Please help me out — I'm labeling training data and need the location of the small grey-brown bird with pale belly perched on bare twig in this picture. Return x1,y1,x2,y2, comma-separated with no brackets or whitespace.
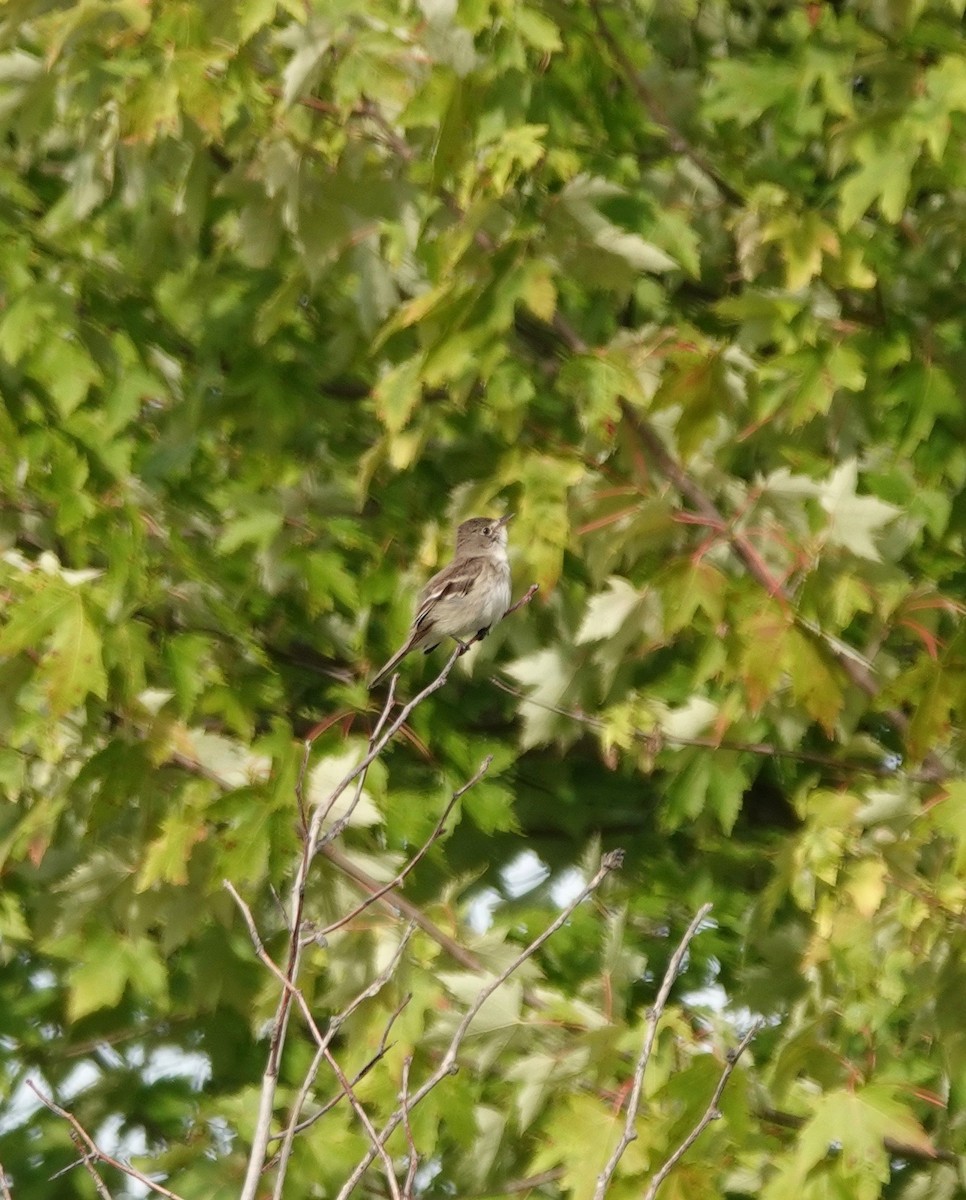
370,515,510,688
